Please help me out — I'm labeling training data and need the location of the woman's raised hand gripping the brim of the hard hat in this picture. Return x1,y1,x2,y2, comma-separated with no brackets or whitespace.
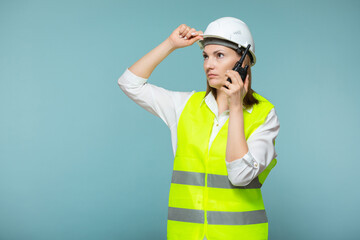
168,24,204,49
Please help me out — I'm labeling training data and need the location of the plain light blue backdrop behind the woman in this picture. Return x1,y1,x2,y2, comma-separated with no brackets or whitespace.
0,0,360,240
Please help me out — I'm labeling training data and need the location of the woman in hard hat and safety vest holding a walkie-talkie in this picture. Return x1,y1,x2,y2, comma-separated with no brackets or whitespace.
118,17,280,240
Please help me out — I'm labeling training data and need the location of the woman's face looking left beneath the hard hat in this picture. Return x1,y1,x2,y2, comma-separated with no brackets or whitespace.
203,44,240,89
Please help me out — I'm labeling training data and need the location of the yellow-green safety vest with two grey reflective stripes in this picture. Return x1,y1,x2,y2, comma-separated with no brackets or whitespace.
167,92,276,240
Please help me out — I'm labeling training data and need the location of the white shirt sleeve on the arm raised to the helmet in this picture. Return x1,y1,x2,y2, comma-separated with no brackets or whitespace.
118,68,194,128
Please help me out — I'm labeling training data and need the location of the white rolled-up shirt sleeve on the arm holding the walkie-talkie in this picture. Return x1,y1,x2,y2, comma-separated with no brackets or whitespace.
226,108,280,186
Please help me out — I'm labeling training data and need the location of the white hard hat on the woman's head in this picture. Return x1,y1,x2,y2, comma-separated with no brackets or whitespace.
197,17,256,66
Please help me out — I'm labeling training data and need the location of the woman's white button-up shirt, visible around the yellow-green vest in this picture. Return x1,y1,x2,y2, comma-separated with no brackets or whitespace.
118,68,280,186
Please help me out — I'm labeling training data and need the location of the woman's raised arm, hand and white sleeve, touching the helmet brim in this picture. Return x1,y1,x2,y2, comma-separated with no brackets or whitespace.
118,24,202,128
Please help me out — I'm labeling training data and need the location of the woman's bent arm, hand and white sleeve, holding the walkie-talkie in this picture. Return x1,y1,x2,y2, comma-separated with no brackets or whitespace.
221,70,280,186
